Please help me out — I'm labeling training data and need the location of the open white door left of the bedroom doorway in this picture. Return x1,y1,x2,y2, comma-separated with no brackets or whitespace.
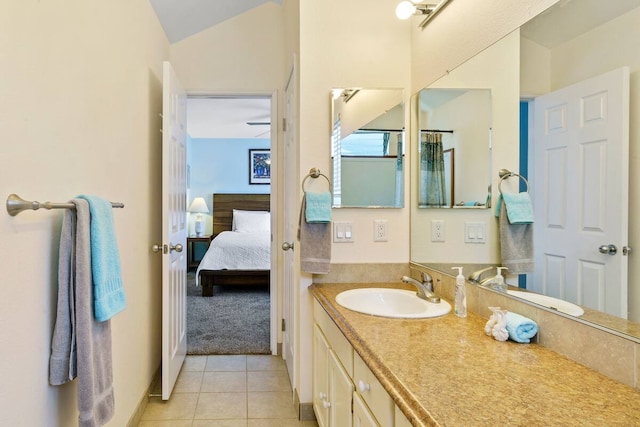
162,62,187,400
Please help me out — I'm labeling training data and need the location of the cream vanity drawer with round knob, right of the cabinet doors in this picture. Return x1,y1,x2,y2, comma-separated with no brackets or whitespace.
353,353,395,426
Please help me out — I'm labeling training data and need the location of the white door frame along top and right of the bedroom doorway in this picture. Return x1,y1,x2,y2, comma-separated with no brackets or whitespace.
186,89,280,356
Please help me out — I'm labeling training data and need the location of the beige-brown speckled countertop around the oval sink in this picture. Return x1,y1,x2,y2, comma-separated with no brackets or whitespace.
310,283,640,426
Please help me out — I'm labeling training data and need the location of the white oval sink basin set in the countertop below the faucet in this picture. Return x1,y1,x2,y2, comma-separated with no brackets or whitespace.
336,288,451,319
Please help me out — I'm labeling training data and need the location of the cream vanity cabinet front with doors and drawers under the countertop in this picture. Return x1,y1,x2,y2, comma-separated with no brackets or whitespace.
313,301,396,427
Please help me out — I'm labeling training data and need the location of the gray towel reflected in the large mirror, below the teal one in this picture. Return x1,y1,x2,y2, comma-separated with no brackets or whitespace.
498,203,533,274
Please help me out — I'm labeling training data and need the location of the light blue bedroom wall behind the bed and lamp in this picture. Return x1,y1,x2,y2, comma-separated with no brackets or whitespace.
188,138,271,234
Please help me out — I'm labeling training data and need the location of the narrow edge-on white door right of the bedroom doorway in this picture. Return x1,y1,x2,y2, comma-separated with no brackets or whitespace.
282,64,298,384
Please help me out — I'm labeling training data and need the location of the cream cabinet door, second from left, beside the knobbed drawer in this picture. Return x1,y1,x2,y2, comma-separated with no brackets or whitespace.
329,350,354,427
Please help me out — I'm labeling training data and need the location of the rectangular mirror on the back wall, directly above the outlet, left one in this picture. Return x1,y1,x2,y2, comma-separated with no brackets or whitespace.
331,88,404,208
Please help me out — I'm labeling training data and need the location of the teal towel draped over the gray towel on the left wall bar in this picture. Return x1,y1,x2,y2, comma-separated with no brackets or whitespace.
78,195,126,322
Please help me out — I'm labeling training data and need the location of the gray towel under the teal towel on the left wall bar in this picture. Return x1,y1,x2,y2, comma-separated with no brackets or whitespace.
49,199,115,427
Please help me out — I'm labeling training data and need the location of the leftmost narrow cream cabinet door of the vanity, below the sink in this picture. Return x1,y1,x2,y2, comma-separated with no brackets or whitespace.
312,324,331,427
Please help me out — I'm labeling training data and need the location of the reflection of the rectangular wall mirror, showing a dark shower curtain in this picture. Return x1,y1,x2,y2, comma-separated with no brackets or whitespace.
418,88,491,208
